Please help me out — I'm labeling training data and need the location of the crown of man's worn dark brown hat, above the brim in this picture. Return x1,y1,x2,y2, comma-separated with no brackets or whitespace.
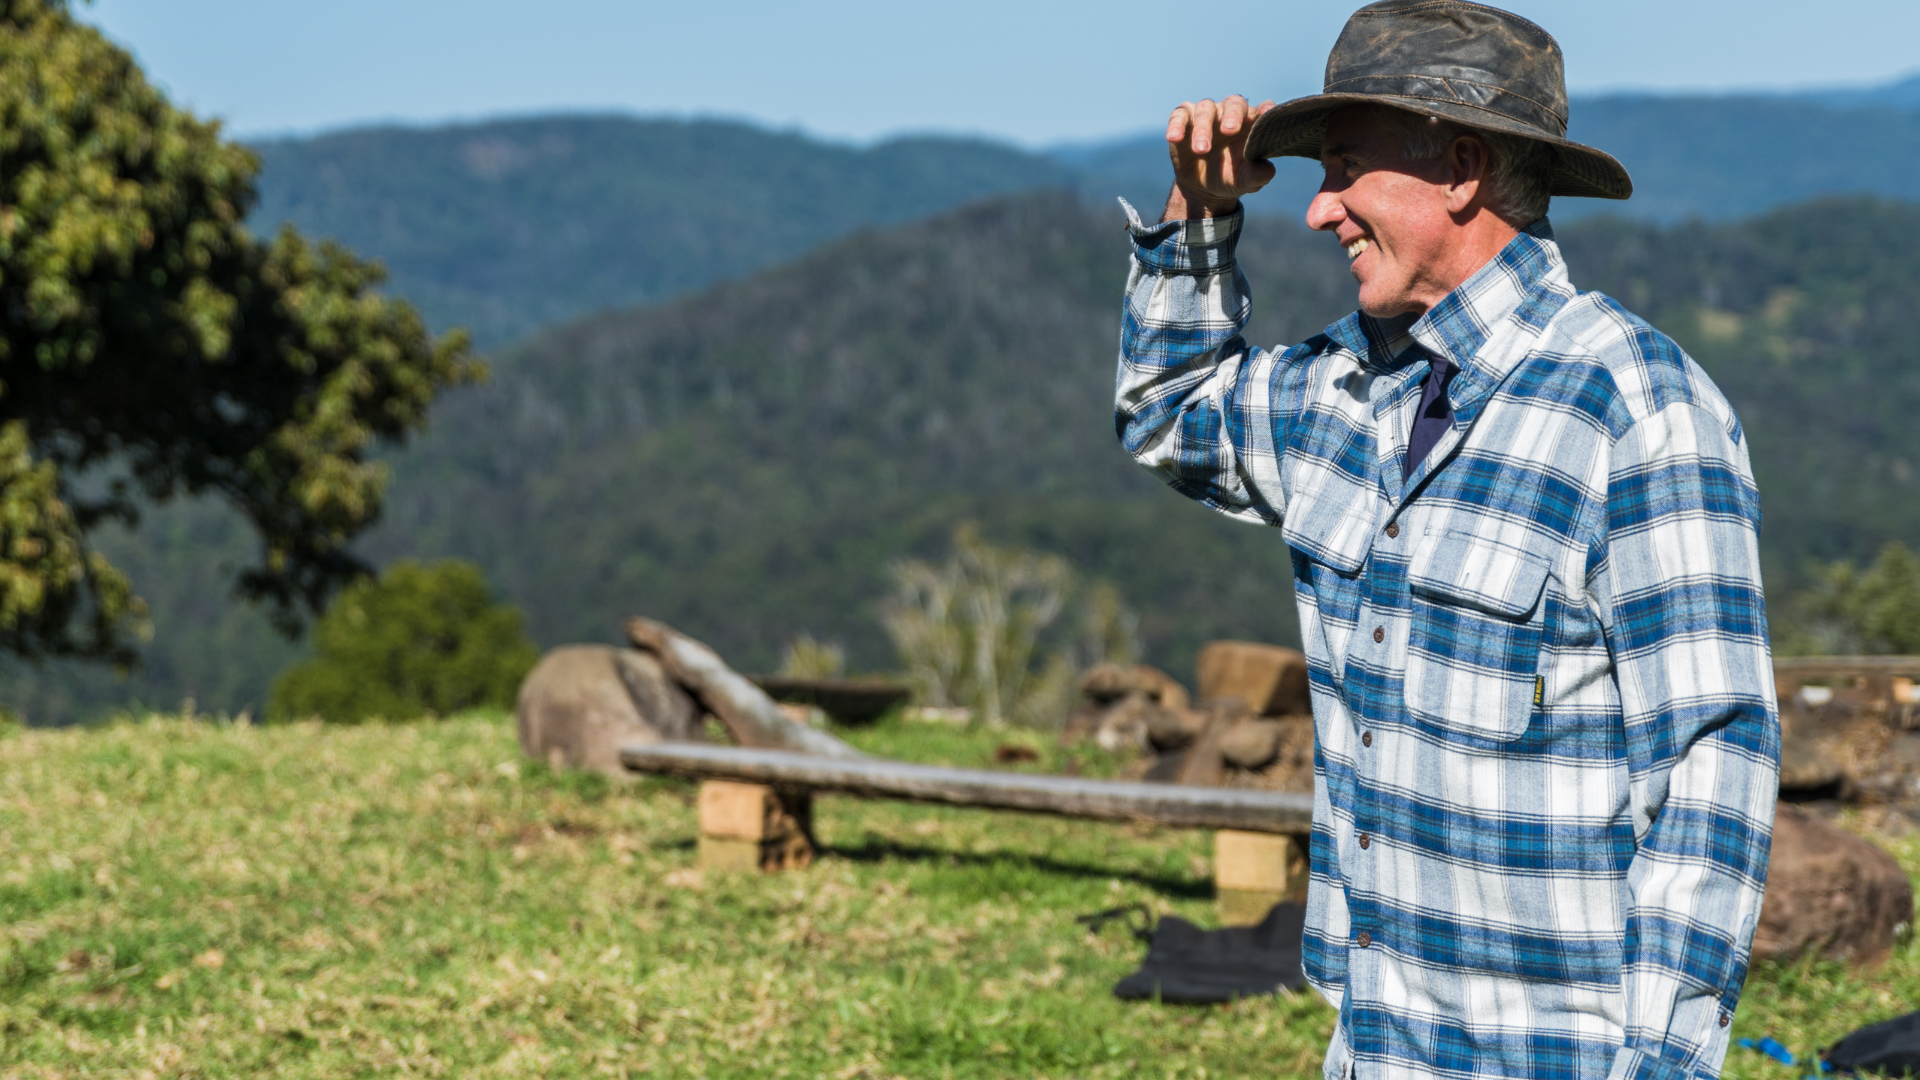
1325,0,1567,136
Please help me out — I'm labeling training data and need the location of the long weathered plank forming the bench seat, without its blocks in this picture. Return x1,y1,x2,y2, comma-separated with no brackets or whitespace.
620,744,1313,836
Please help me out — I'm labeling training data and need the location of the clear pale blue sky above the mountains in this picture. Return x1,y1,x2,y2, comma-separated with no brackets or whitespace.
77,0,1920,144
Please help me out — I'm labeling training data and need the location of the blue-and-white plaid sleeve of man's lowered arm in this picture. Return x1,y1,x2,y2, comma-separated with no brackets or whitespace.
1590,402,1780,1080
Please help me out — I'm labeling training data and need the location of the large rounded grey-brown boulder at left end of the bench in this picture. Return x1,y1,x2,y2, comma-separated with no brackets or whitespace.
515,646,707,776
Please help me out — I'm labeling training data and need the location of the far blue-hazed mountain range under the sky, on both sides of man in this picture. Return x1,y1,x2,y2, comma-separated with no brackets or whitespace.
252,83,1920,350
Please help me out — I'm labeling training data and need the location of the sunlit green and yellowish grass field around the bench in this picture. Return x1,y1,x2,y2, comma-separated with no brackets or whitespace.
0,717,1920,1080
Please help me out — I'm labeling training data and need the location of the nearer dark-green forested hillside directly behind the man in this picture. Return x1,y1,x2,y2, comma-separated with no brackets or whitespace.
8,194,1920,715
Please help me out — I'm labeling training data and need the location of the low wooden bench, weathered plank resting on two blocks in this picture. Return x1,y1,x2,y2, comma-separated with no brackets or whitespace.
620,744,1313,924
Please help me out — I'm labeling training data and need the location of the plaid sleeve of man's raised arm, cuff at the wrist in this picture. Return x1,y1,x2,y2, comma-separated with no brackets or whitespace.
1116,200,1290,525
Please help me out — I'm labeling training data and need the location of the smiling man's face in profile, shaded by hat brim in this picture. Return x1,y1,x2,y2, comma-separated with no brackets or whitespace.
1308,108,1459,319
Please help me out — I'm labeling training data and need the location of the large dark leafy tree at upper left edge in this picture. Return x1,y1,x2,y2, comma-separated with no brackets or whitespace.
0,0,480,661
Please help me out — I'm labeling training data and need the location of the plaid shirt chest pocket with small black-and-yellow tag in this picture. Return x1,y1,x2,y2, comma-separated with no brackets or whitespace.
1405,532,1548,742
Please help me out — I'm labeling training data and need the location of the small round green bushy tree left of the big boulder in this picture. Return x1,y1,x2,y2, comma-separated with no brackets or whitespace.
271,559,540,723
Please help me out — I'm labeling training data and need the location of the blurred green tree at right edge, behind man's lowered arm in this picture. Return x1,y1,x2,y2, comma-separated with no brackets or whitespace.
1782,542,1920,655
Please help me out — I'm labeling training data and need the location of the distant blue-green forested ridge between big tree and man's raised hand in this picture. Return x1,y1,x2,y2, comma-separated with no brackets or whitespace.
252,115,1069,348
